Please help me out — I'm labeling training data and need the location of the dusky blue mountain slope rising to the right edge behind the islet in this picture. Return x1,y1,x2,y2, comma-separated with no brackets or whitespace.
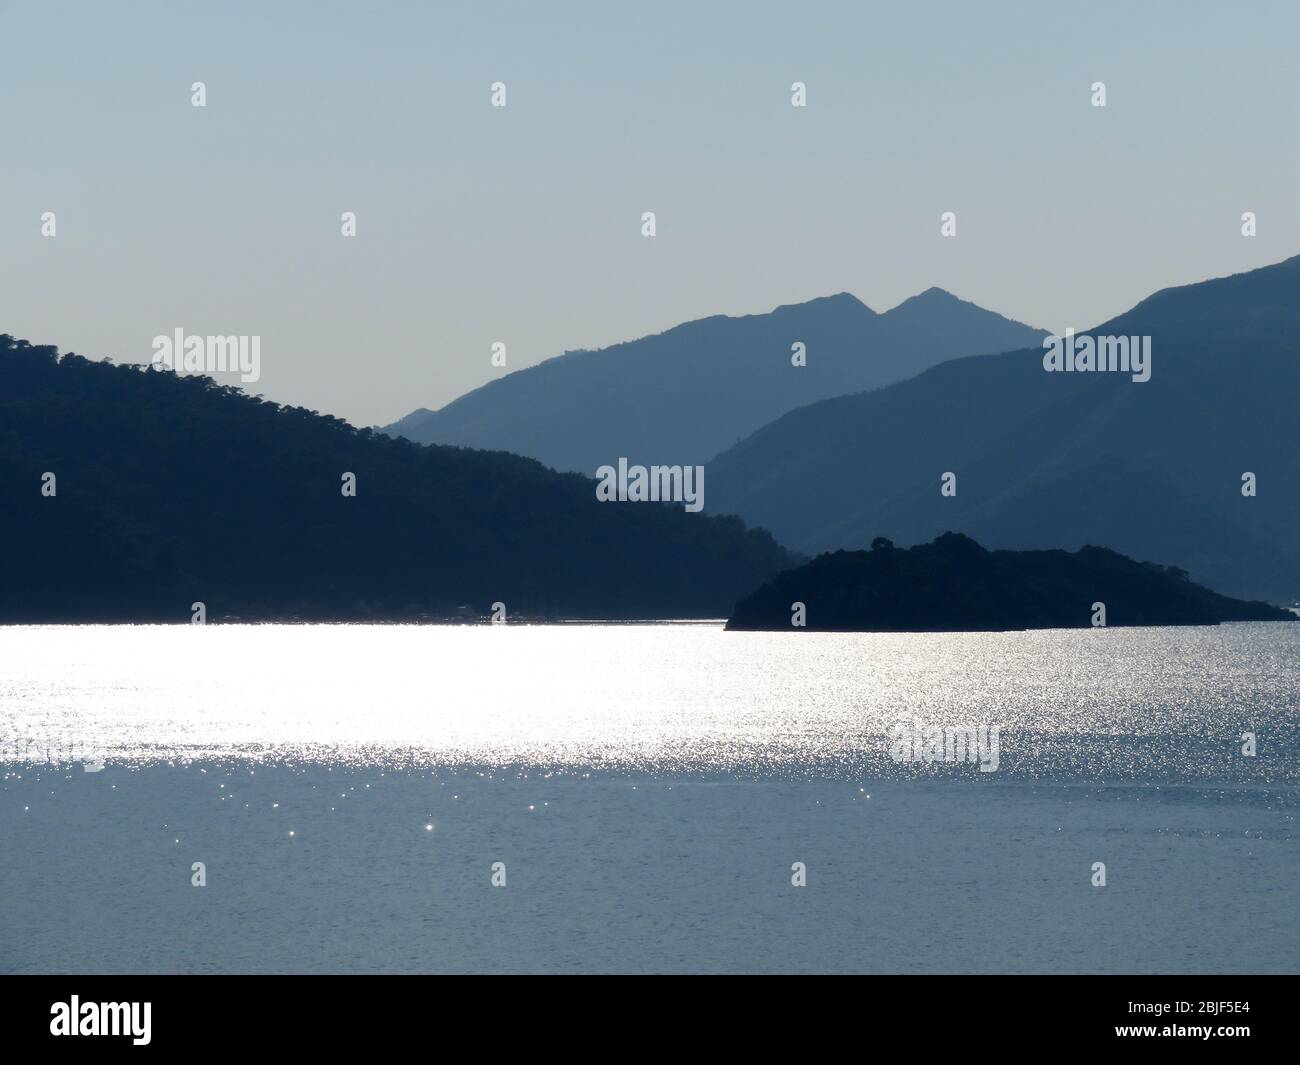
707,248,1300,602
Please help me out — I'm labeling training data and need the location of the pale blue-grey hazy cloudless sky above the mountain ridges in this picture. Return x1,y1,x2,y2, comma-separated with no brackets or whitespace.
0,0,1300,424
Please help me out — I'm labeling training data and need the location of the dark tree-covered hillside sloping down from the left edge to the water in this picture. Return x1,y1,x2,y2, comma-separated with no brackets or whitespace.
0,337,792,624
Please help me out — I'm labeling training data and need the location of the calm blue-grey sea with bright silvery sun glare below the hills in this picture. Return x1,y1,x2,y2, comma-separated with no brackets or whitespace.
0,624,1300,973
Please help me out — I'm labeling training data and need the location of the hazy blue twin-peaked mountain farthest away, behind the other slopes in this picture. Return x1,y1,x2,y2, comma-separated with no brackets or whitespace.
384,289,1043,475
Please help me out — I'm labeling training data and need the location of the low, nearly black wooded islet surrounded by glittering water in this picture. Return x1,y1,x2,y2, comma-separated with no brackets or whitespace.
727,533,1300,632
